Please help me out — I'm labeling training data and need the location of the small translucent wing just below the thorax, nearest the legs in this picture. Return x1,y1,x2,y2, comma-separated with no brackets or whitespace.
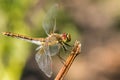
49,43,60,56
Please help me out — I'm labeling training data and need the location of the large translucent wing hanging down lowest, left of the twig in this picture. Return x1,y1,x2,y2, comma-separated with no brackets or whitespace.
35,46,52,77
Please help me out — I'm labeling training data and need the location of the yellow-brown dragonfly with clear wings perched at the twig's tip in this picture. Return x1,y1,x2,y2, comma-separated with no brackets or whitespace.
2,4,71,77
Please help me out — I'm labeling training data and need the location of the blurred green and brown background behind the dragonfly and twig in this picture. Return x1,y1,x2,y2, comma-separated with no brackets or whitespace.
0,0,120,80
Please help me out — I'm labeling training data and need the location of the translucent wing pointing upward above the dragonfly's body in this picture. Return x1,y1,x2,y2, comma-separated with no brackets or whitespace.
42,4,58,35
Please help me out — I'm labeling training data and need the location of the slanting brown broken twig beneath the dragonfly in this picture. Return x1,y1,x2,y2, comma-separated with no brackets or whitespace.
55,41,81,80
